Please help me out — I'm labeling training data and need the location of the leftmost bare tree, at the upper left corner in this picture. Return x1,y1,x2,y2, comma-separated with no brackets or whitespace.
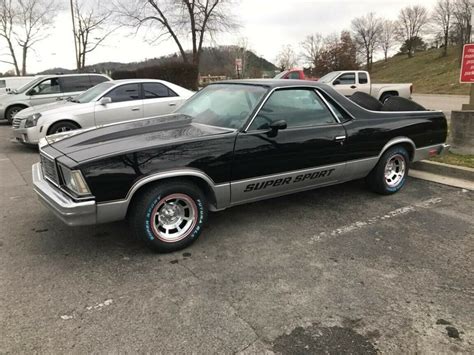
15,0,59,75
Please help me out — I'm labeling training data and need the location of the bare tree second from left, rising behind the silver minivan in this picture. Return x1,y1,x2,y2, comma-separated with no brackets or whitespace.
73,0,117,70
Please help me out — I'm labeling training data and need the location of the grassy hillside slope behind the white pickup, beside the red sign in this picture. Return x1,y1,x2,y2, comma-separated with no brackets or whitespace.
371,47,469,95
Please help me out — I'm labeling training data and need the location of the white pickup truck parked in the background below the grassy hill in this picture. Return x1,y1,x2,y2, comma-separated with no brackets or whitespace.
318,70,413,102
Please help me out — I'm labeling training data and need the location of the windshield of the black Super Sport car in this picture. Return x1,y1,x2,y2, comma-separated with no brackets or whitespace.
176,84,268,128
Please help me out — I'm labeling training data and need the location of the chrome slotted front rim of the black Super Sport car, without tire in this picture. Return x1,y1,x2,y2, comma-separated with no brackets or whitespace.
150,194,198,243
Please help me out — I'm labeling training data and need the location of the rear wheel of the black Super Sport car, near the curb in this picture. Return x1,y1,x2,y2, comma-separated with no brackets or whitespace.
366,146,410,195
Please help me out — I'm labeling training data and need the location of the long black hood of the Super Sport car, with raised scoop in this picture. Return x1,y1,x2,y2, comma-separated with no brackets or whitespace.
46,114,235,163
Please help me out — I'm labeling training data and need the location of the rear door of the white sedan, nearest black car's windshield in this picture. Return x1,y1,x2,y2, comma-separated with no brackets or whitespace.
142,82,184,117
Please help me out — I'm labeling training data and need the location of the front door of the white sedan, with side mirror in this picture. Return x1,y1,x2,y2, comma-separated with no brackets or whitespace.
95,83,143,126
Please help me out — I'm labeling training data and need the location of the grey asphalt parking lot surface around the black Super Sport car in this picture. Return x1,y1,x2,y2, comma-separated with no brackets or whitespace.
0,123,474,354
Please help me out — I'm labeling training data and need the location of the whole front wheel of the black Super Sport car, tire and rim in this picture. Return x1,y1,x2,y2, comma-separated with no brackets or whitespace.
129,181,208,253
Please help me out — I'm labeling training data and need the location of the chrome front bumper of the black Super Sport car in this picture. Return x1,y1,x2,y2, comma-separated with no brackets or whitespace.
32,163,97,226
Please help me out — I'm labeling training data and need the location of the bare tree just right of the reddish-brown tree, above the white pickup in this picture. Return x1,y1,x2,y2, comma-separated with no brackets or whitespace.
352,12,382,71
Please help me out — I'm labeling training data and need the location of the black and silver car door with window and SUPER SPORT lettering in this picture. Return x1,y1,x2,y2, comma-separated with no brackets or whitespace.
231,88,346,204
